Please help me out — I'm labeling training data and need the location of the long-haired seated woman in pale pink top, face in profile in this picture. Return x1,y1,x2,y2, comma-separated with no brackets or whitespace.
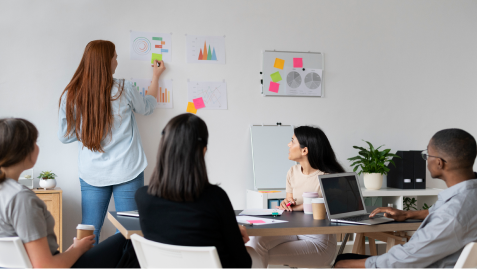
249,126,344,268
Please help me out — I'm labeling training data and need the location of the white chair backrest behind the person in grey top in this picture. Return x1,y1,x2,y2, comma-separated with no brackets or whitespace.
0,237,33,269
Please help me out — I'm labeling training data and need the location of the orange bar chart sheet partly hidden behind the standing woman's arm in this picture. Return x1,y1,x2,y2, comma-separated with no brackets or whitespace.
131,78,173,108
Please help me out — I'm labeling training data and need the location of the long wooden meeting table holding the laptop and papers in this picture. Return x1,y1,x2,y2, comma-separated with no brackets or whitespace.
108,210,421,254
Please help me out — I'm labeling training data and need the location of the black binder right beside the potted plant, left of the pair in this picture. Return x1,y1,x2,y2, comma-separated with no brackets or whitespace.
387,150,414,189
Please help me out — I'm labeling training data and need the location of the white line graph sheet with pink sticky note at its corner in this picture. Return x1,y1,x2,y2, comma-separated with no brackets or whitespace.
187,81,227,109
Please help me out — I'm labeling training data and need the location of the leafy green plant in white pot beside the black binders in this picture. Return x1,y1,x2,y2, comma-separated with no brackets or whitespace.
348,140,400,190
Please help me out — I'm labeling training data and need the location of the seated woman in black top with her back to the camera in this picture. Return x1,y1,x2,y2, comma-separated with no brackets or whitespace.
136,114,254,269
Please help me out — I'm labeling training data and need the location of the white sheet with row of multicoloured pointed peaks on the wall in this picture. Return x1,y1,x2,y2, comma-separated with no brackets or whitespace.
186,35,225,64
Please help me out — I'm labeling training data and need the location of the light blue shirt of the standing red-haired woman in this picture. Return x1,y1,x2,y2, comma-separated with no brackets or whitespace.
58,79,156,187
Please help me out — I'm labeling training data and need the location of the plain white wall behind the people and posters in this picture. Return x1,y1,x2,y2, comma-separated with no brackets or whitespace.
0,0,477,246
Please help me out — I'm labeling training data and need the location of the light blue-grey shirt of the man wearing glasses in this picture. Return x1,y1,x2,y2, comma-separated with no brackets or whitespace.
366,175,477,269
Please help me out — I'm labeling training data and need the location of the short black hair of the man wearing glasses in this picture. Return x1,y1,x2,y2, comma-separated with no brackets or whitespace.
431,129,477,167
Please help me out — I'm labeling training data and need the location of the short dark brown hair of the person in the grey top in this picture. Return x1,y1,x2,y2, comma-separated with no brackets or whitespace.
0,118,38,183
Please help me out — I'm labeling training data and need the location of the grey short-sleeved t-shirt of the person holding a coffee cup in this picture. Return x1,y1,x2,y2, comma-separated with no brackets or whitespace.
0,179,58,254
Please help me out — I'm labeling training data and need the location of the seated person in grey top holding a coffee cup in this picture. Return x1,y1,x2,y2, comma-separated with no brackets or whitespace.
0,118,137,269
